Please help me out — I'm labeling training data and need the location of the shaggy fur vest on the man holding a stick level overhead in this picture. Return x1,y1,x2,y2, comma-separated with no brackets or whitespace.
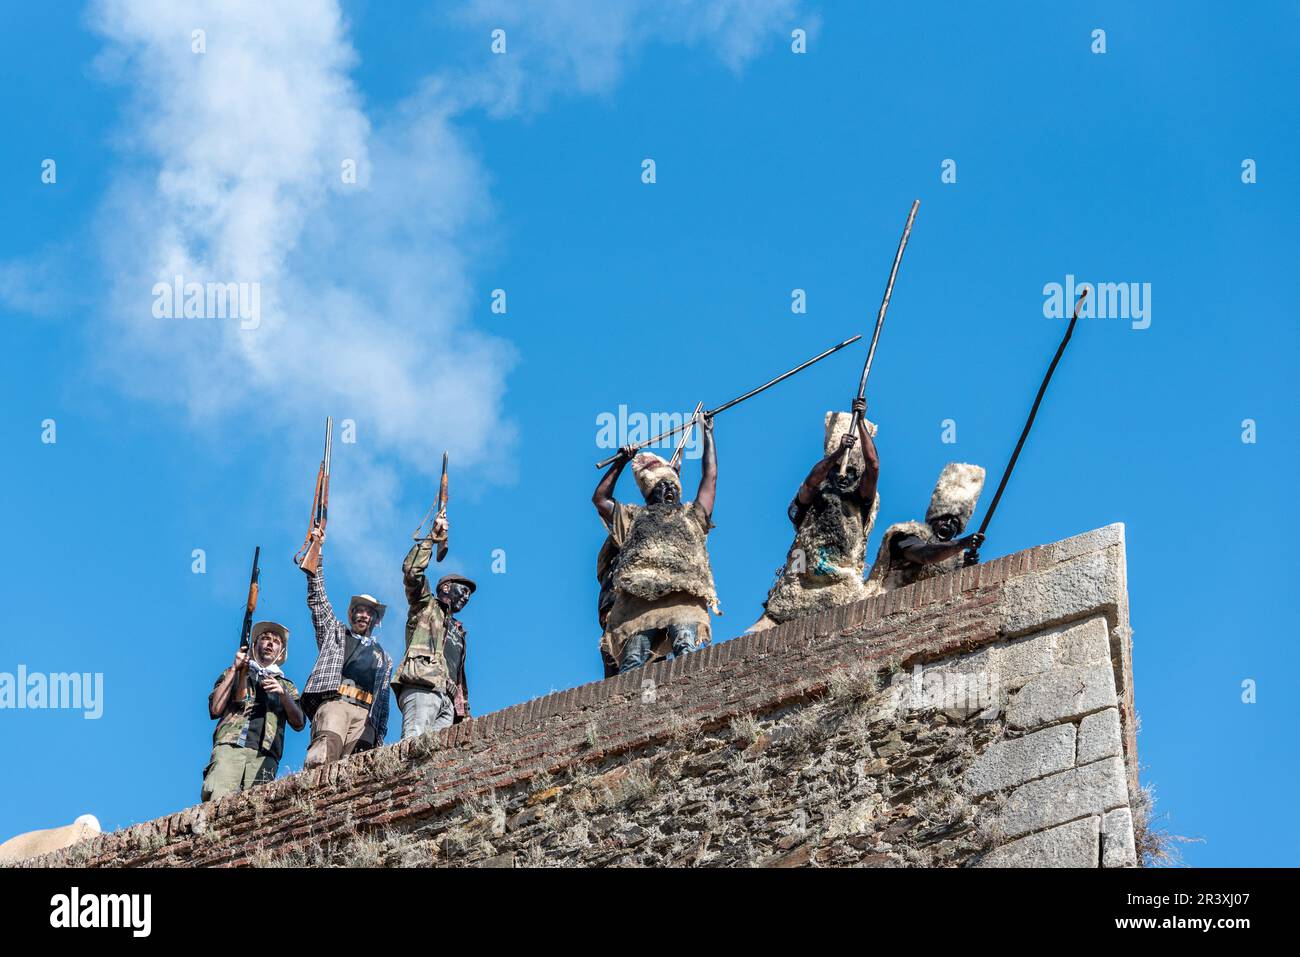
612,503,718,611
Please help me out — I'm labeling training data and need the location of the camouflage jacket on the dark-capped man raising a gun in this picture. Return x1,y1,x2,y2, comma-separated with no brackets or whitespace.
393,538,469,720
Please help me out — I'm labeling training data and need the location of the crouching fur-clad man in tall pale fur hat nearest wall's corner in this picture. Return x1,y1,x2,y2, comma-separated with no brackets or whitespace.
867,462,984,594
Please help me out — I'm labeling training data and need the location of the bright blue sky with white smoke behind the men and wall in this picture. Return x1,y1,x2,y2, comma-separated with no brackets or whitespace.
0,0,1300,865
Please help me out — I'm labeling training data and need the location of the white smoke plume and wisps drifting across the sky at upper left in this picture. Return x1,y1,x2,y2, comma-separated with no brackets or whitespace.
17,0,797,572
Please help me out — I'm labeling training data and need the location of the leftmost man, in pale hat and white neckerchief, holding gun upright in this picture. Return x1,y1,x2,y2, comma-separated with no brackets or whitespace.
202,622,307,801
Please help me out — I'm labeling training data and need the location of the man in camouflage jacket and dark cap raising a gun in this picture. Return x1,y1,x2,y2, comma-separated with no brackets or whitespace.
393,516,475,741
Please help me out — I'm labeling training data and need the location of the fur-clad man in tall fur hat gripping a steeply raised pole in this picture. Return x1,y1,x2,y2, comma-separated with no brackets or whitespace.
749,399,880,632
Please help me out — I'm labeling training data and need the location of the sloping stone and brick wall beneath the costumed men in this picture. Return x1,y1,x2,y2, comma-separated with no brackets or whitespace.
30,525,1138,867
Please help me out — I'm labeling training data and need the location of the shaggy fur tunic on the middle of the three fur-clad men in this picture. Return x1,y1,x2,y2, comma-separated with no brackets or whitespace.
764,482,880,623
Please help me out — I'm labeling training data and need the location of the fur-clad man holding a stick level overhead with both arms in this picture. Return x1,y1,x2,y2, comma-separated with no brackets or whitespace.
592,419,722,674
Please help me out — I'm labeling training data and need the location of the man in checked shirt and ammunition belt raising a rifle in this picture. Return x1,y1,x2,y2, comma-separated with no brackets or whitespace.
303,531,393,768
